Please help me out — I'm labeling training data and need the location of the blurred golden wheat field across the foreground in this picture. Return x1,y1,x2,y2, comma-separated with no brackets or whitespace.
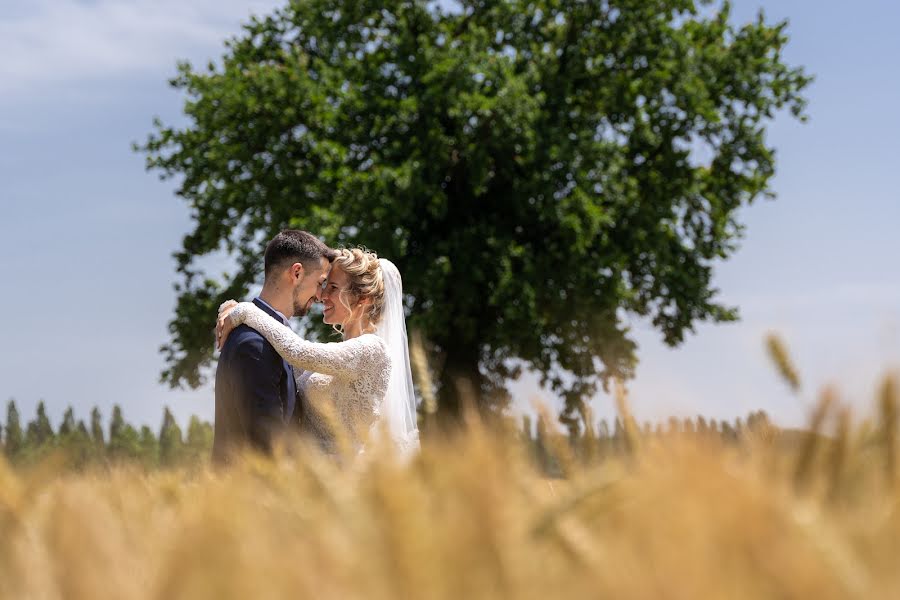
0,381,900,599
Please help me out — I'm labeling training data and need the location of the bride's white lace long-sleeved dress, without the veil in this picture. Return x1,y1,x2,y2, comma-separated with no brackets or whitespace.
229,302,391,451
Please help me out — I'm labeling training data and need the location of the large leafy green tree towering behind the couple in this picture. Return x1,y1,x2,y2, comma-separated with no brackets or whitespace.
137,0,810,416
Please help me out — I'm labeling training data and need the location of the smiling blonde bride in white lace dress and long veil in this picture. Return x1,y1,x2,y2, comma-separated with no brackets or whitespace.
216,248,419,453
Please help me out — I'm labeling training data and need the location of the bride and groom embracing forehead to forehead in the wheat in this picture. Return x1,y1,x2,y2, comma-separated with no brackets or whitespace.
213,230,419,463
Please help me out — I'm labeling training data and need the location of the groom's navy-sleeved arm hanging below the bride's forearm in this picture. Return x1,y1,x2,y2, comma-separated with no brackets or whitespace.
236,331,284,453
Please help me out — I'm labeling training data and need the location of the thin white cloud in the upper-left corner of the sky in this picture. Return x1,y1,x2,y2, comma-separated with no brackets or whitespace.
0,0,282,95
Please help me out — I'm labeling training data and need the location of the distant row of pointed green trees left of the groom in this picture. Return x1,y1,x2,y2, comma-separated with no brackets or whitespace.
0,400,213,469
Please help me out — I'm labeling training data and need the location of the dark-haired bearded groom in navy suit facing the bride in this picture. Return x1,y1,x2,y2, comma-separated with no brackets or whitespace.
213,230,335,463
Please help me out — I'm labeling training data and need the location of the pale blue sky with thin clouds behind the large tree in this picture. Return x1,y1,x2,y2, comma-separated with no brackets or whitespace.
0,0,900,426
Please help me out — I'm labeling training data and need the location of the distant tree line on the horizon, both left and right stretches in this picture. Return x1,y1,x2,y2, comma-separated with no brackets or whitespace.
0,400,773,476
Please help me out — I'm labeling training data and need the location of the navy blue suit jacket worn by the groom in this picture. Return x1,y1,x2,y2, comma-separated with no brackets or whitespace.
213,300,297,462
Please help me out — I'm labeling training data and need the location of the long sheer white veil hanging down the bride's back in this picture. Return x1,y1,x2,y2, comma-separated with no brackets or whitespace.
376,258,419,454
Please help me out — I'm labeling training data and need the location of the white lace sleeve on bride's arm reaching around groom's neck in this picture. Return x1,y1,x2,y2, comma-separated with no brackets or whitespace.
229,302,380,375
